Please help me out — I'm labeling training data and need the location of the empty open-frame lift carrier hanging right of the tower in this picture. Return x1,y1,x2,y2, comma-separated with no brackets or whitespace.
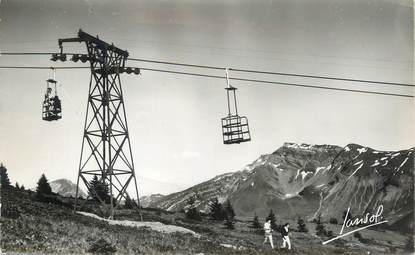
222,68,251,144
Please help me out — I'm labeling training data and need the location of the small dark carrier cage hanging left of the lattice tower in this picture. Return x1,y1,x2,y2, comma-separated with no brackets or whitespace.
42,70,62,121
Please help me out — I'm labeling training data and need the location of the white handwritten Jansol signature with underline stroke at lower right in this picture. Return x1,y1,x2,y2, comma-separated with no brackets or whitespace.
323,205,388,245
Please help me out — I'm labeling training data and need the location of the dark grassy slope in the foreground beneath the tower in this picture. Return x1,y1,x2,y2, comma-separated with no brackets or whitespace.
1,188,410,255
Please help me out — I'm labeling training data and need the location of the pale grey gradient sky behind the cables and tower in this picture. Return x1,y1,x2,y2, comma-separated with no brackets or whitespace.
0,0,415,195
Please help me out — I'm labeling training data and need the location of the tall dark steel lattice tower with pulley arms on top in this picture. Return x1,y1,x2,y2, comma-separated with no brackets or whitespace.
51,30,140,217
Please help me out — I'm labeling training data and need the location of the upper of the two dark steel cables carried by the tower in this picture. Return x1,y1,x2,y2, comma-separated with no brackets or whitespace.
0,52,415,87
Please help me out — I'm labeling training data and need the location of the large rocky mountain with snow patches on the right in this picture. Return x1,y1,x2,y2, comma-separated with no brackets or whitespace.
148,143,415,232
